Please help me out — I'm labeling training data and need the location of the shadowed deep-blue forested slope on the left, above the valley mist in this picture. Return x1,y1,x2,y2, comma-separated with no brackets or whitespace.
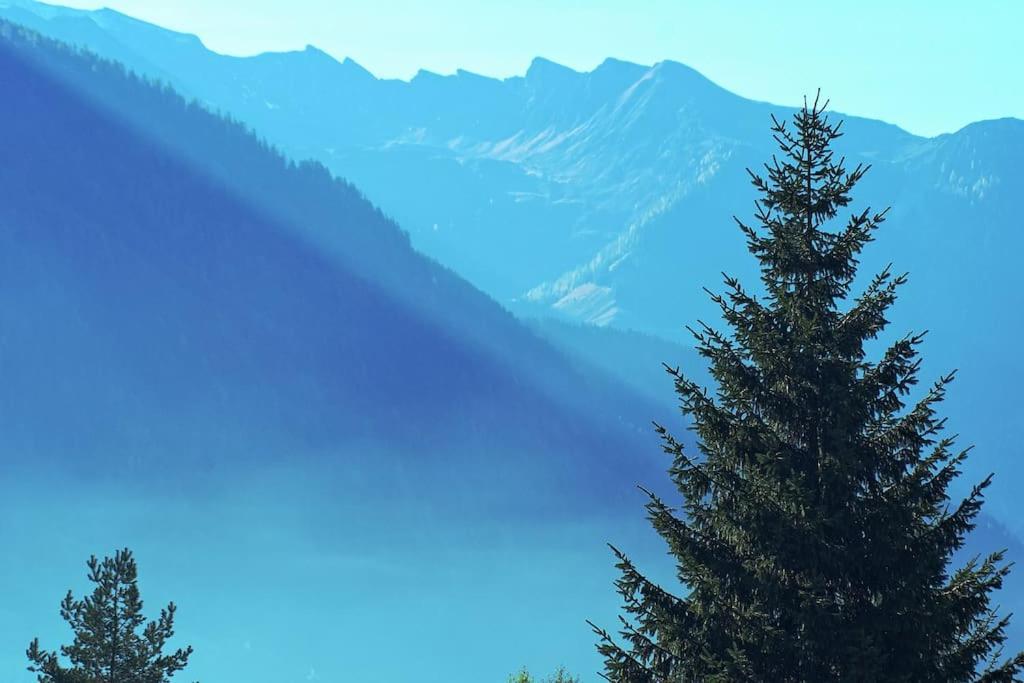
0,18,671,499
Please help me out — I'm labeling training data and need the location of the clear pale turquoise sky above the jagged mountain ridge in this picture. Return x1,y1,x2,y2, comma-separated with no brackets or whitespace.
59,0,1024,135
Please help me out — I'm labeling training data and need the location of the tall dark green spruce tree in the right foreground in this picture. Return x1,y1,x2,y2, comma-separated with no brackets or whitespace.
592,93,1024,683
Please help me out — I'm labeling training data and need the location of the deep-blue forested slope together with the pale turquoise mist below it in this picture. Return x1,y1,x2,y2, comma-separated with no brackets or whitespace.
0,23,679,681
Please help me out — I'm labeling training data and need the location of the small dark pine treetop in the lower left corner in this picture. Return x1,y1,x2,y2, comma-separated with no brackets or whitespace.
27,549,193,683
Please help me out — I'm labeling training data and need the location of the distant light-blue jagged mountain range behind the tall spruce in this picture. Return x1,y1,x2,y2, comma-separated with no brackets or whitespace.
16,0,1024,531
